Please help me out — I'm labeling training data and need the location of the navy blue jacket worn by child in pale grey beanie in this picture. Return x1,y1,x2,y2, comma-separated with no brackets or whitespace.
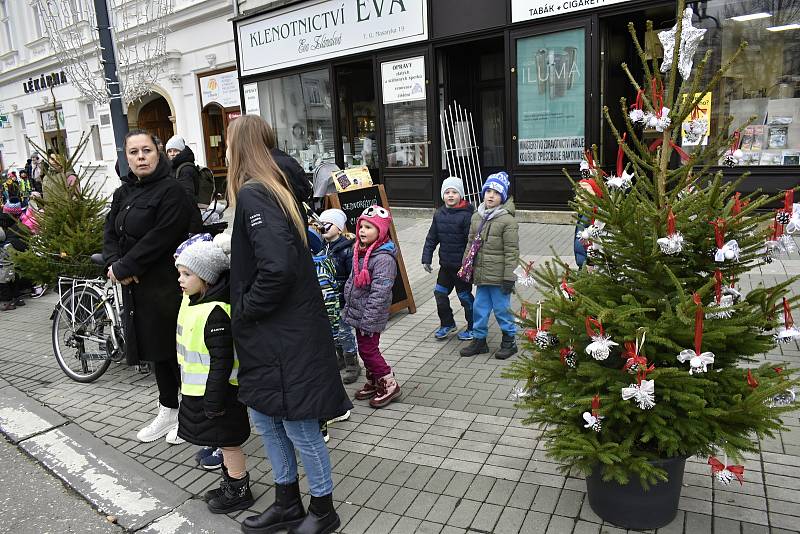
422,203,475,268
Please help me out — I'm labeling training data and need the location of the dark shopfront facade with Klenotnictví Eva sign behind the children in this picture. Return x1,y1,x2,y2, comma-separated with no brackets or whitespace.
234,0,800,209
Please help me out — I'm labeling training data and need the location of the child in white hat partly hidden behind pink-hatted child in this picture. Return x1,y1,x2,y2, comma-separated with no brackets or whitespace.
319,209,361,384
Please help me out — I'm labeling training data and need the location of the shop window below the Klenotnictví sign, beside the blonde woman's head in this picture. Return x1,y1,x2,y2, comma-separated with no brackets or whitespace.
258,70,335,172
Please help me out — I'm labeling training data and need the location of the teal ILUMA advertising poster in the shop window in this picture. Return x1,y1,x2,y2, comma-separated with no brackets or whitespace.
517,29,586,165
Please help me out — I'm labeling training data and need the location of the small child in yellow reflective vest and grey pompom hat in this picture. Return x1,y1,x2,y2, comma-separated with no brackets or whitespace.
175,234,254,514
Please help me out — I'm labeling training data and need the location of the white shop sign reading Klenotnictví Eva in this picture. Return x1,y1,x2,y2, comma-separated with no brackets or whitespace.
236,0,428,76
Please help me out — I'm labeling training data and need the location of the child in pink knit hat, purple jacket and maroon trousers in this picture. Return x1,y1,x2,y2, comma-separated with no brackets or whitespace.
342,206,400,408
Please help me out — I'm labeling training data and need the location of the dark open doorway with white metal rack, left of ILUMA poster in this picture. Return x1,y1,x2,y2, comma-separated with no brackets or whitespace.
438,37,506,186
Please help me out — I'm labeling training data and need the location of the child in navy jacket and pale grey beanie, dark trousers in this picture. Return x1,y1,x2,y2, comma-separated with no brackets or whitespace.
422,176,475,341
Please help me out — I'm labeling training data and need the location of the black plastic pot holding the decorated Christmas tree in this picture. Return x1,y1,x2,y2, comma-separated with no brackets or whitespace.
586,458,686,530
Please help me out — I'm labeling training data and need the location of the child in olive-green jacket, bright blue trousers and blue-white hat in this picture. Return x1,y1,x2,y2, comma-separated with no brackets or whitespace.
459,172,519,360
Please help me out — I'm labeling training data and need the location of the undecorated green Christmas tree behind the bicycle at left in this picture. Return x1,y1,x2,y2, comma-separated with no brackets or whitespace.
13,134,106,284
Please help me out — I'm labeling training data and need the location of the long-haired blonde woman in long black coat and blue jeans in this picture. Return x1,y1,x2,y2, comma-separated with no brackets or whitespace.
228,115,352,534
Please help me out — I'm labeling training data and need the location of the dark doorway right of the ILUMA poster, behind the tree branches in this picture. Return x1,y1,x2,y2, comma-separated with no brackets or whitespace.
599,6,675,169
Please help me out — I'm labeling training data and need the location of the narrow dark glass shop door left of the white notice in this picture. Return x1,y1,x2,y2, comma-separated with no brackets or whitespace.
334,61,380,183
